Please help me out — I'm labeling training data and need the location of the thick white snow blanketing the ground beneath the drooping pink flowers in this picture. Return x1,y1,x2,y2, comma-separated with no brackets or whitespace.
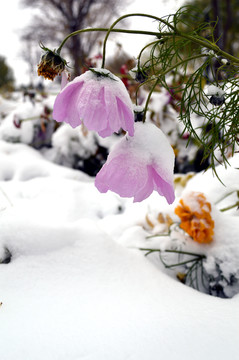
0,91,239,360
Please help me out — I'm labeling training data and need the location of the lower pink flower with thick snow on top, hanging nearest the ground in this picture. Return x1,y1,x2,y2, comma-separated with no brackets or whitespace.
95,123,175,204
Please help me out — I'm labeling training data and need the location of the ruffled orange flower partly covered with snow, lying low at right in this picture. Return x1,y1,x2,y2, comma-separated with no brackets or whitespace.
175,192,214,244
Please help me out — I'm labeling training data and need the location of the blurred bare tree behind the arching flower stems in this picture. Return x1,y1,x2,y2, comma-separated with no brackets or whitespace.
21,0,127,75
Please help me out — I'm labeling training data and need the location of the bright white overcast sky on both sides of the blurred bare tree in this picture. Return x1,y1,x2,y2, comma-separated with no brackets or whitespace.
0,0,183,84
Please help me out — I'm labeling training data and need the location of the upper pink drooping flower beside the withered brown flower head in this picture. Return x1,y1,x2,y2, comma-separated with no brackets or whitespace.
53,69,134,137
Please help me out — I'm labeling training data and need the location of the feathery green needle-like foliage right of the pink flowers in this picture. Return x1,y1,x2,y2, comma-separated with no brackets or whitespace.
136,7,239,177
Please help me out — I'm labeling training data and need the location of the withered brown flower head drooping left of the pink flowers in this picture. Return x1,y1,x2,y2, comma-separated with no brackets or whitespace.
37,45,66,80
